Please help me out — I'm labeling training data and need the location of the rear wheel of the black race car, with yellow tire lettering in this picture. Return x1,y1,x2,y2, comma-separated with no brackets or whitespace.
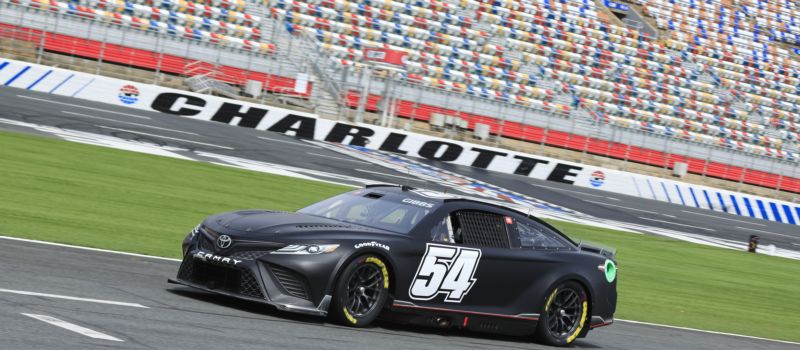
536,281,589,346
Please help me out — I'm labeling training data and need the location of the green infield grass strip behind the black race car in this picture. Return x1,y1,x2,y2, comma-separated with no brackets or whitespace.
0,132,800,341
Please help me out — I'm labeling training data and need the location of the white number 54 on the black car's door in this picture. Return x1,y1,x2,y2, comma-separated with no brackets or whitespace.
408,243,481,303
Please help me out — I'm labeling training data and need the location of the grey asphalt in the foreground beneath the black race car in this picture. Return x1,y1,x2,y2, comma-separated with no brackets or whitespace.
0,239,800,350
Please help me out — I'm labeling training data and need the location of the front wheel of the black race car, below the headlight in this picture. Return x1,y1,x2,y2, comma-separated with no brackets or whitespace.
328,255,389,327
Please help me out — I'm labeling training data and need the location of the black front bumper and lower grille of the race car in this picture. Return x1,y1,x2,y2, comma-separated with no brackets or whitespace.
168,247,331,316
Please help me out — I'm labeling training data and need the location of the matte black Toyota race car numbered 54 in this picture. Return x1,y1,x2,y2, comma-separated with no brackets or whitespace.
170,185,617,345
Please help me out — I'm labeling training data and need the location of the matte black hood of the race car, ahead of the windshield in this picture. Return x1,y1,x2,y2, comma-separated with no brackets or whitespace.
205,210,391,237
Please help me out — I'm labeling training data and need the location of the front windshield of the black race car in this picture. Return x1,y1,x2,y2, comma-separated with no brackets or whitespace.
297,189,439,233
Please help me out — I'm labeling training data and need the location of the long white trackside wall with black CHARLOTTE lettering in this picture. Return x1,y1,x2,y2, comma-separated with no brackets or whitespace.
0,60,800,225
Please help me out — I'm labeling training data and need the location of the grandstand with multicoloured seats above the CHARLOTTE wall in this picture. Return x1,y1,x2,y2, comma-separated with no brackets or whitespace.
0,0,800,198
